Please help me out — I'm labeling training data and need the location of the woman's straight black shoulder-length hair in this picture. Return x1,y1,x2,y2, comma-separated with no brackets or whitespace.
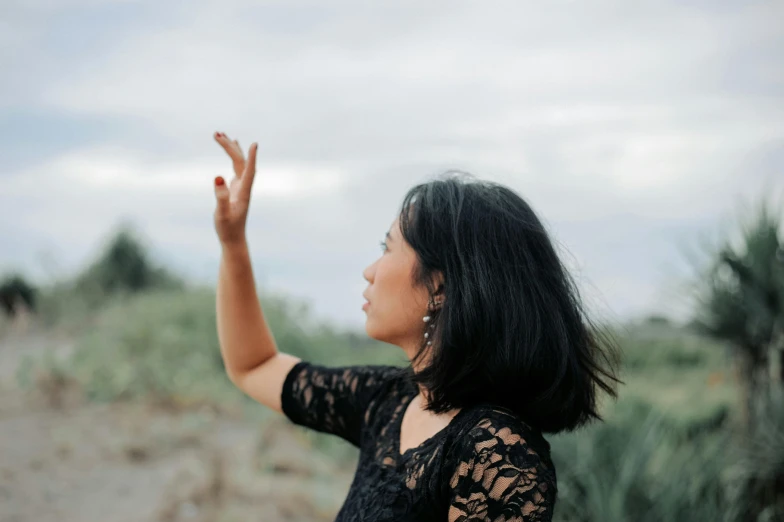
400,171,621,433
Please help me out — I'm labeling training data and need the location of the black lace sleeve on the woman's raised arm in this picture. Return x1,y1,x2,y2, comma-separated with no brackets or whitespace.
281,361,400,447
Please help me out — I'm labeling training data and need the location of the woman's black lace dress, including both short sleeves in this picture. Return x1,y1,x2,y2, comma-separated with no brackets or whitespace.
281,361,556,522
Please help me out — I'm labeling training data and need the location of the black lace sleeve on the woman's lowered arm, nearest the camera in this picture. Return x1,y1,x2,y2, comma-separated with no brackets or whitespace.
449,418,556,522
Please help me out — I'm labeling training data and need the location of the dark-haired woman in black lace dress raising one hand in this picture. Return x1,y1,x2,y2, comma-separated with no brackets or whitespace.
215,133,618,522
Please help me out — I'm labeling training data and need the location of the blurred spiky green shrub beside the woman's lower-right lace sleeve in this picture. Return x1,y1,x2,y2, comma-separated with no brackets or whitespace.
551,402,725,522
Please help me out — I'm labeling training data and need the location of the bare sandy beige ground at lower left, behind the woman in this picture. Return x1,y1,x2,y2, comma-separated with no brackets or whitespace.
0,332,353,522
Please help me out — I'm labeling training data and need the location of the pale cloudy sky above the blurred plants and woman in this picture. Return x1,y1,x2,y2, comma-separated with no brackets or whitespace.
0,0,784,326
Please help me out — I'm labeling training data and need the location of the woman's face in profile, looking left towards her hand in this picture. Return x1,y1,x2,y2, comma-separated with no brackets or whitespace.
362,212,438,357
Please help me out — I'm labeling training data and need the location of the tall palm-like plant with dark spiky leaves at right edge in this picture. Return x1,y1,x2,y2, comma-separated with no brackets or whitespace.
695,195,784,520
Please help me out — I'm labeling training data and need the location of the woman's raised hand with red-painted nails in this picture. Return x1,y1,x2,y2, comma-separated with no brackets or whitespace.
214,132,258,246
